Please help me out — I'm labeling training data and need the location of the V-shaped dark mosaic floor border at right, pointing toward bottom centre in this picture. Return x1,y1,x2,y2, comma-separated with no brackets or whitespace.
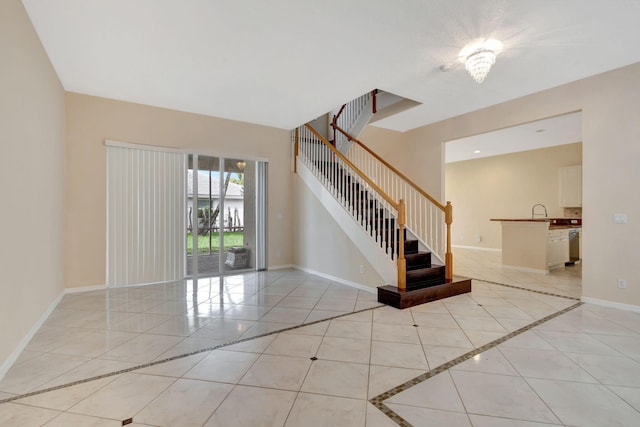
369,300,582,427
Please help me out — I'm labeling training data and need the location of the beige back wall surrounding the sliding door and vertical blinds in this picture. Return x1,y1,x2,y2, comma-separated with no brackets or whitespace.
65,93,293,287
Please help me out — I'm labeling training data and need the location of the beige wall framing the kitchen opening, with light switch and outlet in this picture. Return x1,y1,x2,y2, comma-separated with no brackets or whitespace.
378,64,640,306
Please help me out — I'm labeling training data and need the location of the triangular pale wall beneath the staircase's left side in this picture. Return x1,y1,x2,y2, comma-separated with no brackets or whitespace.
293,176,386,288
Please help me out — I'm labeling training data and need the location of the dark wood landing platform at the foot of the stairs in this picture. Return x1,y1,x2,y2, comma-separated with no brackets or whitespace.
378,276,471,308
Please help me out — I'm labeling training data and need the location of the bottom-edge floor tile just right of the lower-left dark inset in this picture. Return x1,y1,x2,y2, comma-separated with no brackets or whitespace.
135,379,233,427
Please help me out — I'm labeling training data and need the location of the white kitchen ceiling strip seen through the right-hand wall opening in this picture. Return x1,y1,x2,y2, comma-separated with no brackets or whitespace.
445,112,582,163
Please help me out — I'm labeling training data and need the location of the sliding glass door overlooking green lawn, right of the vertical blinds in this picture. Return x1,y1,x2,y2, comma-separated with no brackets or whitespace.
186,155,266,277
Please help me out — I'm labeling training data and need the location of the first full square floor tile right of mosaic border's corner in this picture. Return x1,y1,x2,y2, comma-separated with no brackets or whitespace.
451,371,558,423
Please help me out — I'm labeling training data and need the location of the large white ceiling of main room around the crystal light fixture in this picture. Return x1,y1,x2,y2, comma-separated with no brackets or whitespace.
23,0,640,131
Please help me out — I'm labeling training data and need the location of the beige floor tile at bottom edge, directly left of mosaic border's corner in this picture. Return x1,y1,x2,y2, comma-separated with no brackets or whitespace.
285,393,367,427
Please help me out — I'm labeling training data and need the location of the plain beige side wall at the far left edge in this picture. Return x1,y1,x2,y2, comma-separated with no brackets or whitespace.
0,0,64,370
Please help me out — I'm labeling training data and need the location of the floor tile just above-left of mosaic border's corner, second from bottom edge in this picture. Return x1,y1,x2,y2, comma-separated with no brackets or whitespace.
301,360,369,399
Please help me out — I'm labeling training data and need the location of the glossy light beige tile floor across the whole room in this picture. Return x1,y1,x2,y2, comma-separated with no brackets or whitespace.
0,251,640,427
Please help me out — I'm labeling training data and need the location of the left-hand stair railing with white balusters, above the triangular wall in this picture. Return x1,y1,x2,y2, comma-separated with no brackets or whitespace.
292,124,406,290
